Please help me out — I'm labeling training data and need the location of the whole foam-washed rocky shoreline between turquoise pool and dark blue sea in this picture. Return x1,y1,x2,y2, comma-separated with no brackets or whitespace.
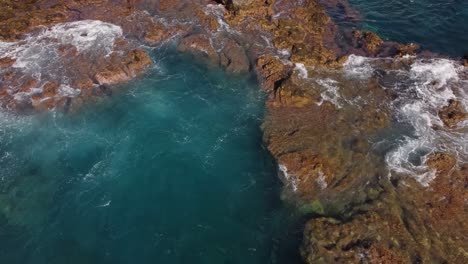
0,0,468,263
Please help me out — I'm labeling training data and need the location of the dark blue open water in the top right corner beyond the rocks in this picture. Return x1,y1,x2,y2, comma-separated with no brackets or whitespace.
349,0,468,57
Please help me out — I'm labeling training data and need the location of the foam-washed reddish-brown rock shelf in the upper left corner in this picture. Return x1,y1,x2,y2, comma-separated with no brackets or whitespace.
0,0,193,113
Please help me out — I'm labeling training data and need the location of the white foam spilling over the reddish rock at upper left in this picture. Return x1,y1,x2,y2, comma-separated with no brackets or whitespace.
0,20,123,104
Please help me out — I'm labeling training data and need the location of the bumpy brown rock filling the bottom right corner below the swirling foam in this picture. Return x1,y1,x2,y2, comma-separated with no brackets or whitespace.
301,150,468,263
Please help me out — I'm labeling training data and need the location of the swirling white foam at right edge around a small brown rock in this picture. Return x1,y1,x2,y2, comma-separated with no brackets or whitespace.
386,59,468,186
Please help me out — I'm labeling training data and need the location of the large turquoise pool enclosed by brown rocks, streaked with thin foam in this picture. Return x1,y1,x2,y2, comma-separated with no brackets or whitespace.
0,51,301,264
